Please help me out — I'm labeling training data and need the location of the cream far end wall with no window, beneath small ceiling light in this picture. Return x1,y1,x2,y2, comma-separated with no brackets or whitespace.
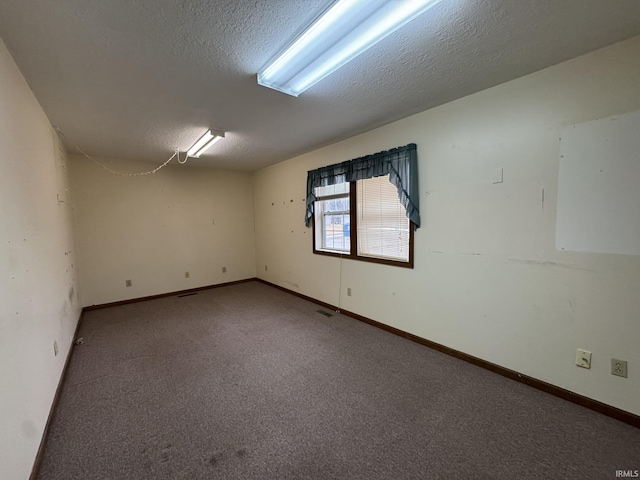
70,155,255,306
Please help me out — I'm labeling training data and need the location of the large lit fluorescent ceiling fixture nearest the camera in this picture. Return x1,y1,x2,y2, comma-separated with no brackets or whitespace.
258,0,441,97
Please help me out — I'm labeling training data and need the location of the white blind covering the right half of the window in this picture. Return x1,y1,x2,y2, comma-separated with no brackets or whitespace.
356,175,410,262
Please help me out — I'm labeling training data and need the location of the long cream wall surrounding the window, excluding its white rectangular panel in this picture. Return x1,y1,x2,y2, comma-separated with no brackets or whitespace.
254,37,640,414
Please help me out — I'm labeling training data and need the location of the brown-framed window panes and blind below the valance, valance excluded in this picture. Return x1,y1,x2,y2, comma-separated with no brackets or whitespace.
313,175,413,268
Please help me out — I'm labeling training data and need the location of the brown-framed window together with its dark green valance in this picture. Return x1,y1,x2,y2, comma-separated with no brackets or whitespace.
304,143,420,268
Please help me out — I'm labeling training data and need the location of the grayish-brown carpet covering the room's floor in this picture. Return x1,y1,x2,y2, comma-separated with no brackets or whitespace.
38,282,640,480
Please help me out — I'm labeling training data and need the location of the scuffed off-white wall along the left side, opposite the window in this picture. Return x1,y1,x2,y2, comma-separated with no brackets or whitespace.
0,40,80,479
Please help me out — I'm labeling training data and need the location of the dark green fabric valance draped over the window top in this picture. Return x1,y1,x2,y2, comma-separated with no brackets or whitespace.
305,143,420,228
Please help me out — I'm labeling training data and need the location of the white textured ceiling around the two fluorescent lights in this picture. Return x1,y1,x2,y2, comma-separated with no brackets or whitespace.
0,0,640,170
